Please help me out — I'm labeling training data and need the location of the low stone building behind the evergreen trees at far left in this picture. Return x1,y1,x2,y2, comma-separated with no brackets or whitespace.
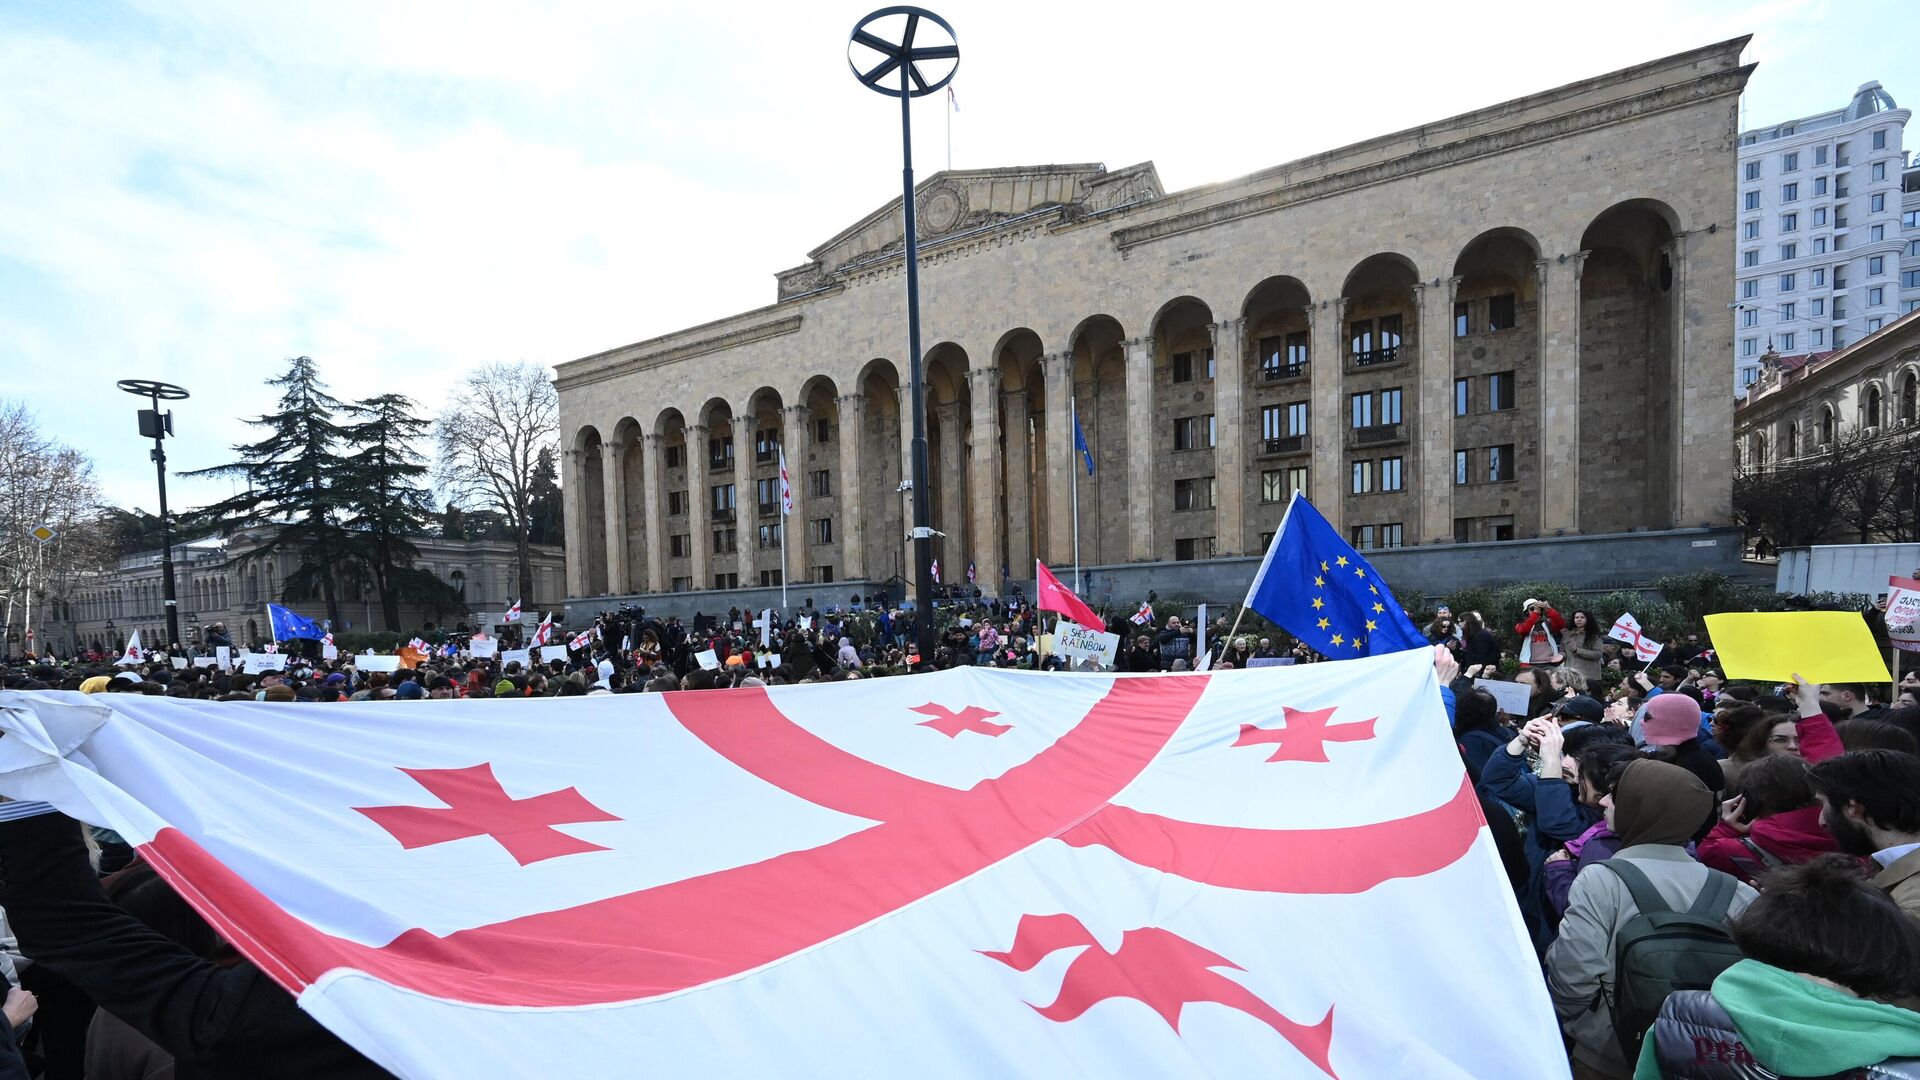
46,532,566,650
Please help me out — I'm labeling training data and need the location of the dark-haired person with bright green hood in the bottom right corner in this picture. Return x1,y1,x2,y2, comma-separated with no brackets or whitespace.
1634,855,1920,1080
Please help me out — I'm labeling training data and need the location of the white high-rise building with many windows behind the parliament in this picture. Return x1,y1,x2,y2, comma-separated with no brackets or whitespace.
1732,83,1920,396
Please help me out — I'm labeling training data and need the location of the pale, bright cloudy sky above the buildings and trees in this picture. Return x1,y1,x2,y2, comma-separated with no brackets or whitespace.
0,0,1920,509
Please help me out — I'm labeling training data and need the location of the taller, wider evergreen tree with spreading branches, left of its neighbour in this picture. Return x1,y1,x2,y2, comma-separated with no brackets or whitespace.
182,356,349,625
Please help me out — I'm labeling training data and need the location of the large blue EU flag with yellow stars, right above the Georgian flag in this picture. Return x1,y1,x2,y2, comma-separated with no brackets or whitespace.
1246,492,1427,659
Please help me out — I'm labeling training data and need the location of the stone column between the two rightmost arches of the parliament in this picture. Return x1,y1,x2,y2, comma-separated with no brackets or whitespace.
1534,252,1586,536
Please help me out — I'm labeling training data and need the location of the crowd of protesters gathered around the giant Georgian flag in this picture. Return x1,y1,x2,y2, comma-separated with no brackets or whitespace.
0,596,1920,1080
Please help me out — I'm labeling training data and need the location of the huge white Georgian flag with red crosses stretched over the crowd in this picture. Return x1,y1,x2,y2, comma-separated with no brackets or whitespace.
0,650,1567,1080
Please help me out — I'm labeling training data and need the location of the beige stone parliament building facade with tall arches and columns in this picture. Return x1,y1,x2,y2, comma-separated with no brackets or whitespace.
557,38,1751,598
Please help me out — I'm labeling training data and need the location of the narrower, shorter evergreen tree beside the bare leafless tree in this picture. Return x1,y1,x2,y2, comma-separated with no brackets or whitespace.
334,394,438,632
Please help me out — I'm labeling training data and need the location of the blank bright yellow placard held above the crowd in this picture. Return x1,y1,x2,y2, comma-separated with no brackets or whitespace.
1707,611,1893,682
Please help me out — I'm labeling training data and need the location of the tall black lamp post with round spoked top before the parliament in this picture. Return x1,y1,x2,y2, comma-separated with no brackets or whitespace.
847,6,960,661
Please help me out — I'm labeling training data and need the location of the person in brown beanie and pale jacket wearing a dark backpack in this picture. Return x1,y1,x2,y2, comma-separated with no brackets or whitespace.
1546,759,1755,1080
